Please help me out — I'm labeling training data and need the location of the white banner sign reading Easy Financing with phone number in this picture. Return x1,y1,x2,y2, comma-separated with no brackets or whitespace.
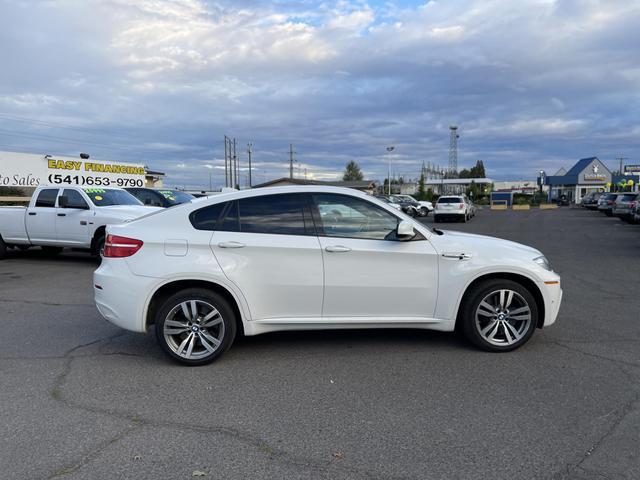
0,152,145,188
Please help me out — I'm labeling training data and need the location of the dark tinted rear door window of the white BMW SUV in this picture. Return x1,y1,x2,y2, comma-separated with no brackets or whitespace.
235,194,311,235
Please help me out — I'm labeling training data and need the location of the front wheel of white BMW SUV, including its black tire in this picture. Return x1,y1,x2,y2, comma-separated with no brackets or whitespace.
458,279,538,352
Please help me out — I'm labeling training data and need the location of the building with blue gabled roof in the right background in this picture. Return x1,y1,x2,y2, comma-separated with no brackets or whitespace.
542,157,639,203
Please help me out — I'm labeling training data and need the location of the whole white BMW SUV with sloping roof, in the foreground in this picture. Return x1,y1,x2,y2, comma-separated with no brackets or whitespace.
94,186,562,365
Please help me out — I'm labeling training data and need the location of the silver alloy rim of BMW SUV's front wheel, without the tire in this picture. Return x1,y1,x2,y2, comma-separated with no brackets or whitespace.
475,289,531,347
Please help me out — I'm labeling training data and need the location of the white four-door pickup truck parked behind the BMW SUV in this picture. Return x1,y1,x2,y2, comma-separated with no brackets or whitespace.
0,186,162,260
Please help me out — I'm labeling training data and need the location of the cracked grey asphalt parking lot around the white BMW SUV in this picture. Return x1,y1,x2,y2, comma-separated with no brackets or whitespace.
0,208,640,480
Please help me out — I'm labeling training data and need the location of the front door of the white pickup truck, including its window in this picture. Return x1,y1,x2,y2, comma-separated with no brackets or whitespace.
56,189,93,246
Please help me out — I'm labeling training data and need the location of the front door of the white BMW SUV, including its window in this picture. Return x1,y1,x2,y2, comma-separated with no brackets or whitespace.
312,193,438,320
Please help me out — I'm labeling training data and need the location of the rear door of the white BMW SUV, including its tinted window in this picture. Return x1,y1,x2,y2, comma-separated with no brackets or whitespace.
211,193,323,320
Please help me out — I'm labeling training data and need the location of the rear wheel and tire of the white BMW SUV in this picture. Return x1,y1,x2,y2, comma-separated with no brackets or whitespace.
155,288,236,366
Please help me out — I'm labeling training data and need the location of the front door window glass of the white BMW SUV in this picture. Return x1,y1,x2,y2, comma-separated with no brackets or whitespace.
313,193,399,240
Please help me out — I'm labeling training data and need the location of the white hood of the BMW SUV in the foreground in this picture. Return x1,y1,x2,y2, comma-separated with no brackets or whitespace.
435,230,542,258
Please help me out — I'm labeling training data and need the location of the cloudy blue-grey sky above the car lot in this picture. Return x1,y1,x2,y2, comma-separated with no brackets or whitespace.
0,0,640,188
